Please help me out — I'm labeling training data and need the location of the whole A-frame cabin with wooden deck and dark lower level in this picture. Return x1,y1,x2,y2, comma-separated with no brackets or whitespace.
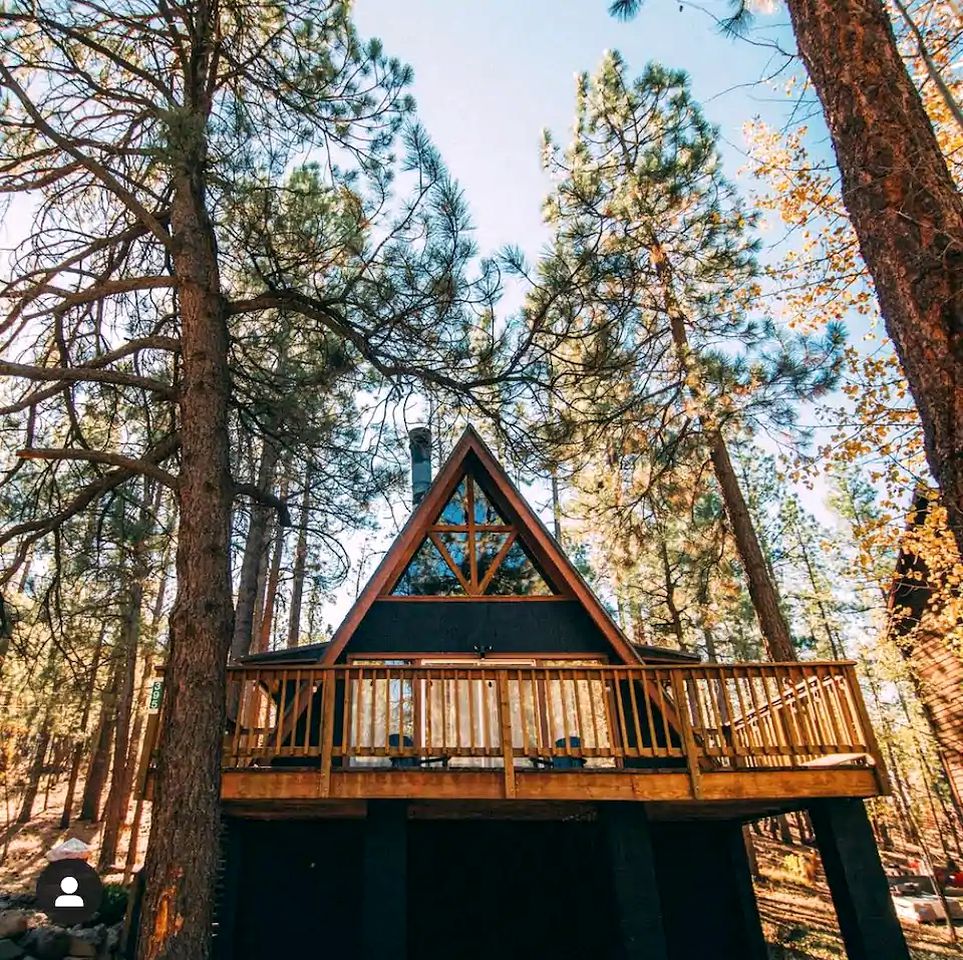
145,429,908,960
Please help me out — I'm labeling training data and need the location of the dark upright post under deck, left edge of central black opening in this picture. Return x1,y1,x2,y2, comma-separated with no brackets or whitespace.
360,800,408,960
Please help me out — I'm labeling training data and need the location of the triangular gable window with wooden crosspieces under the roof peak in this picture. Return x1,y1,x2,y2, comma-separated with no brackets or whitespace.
391,475,555,597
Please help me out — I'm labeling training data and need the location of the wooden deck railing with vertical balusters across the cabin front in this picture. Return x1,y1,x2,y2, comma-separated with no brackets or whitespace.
223,662,880,788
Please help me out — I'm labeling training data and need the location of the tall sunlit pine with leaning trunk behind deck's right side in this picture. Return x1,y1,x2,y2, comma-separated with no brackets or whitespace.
543,54,841,659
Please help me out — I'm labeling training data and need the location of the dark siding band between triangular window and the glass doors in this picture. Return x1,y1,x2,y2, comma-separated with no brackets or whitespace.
345,600,611,656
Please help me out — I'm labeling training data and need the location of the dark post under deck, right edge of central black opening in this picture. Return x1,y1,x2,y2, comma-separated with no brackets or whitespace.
598,801,669,960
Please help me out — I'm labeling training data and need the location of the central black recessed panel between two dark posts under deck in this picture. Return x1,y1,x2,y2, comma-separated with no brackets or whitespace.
408,820,622,960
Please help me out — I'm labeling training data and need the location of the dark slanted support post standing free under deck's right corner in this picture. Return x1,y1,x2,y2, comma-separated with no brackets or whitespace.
809,797,909,960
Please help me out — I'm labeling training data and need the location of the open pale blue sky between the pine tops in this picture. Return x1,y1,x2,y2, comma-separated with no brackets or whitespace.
355,0,793,256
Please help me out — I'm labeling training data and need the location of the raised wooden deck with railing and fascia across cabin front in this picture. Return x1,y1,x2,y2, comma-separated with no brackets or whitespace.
200,661,887,814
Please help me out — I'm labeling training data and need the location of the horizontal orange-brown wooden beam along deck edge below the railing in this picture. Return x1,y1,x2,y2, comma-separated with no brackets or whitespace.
221,767,880,813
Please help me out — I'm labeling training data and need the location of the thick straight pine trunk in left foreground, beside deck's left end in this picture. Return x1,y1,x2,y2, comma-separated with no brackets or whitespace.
137,67,234,960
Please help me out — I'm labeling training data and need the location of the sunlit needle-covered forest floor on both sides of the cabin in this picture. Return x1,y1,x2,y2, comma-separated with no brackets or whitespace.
0,784,963,960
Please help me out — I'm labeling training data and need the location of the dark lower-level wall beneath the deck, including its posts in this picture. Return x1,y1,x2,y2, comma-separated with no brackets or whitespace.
215,801,784,960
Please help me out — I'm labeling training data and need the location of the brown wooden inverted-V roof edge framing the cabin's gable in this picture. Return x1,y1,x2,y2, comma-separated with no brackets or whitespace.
320,426,640,664
